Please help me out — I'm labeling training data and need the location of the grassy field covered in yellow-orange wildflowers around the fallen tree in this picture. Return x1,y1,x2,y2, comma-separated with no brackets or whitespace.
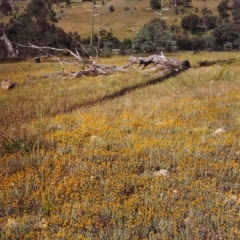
0,52,240,240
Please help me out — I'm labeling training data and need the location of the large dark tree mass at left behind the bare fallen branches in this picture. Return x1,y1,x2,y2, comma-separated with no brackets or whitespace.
0,0,80,57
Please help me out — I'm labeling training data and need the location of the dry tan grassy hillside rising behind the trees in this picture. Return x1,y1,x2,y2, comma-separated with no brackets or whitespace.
0,0,221,40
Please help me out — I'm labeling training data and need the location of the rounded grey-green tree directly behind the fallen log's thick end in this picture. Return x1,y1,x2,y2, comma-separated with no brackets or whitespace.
133,18,176,53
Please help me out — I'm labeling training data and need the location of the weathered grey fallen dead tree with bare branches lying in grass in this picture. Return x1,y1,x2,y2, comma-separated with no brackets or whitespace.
15,43,191,78
